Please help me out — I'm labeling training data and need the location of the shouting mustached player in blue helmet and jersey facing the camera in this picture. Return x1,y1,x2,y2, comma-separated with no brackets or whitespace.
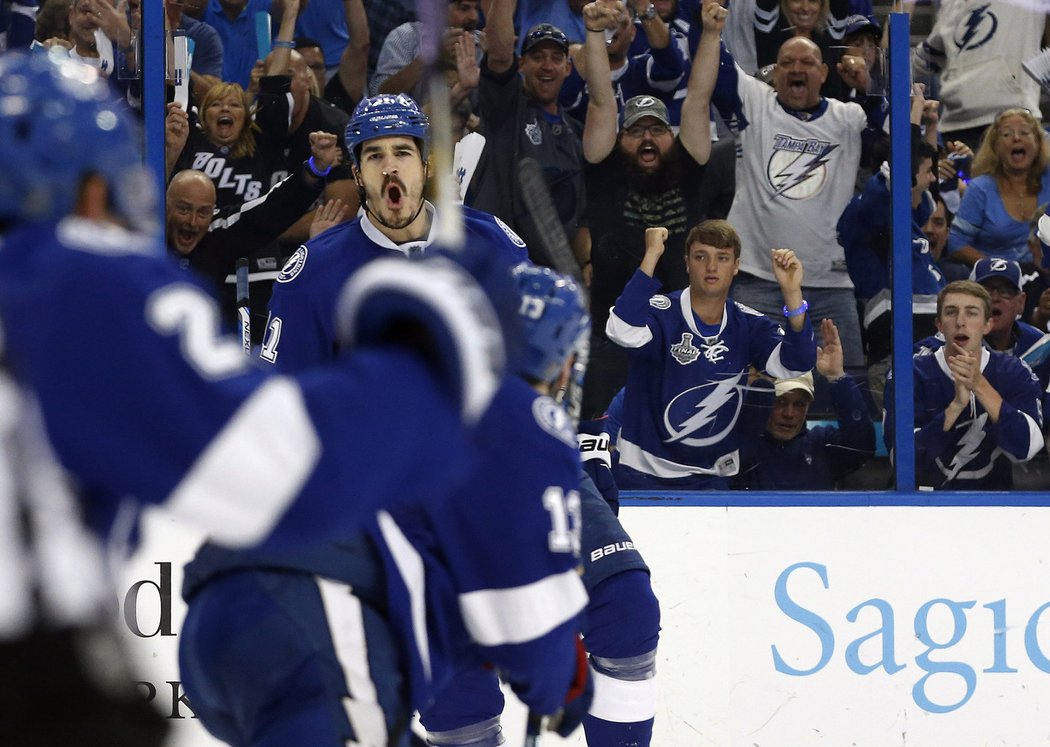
260,94,527,370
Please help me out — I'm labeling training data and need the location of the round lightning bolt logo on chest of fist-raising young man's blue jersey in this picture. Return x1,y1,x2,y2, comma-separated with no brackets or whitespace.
664,377,743,447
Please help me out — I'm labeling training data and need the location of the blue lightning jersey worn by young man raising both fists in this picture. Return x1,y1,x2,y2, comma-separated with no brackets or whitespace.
606,270,817,487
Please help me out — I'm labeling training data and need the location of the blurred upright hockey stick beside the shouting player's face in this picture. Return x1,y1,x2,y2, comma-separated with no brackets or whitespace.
416,0,463,249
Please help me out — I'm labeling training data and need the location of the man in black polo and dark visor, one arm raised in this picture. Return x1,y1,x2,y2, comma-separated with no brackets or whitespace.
465,0,584,266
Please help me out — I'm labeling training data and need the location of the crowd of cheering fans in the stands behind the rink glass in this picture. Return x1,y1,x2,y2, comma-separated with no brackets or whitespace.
0,0,1050,489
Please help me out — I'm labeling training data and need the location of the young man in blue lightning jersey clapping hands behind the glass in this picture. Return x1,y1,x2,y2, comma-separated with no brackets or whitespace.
883,281,1044,491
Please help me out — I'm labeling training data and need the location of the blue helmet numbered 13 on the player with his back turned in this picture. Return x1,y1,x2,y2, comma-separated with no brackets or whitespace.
510,263,590,381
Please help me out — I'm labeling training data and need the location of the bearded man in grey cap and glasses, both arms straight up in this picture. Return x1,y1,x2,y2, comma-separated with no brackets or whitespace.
578,2,735,417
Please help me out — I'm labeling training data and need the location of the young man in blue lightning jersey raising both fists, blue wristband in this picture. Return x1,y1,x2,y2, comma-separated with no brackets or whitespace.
606,221,817,490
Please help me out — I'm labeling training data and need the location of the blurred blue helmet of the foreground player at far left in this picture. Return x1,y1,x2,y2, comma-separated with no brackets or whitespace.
0,53,158,230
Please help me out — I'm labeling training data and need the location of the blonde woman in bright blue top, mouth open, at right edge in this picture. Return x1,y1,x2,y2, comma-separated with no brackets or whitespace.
947,108,1050,265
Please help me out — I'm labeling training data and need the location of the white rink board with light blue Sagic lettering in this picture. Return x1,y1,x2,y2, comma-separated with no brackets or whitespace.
120,506,1050,747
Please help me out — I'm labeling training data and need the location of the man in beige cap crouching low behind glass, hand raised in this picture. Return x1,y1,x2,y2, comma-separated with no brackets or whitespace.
732,319,875,491
